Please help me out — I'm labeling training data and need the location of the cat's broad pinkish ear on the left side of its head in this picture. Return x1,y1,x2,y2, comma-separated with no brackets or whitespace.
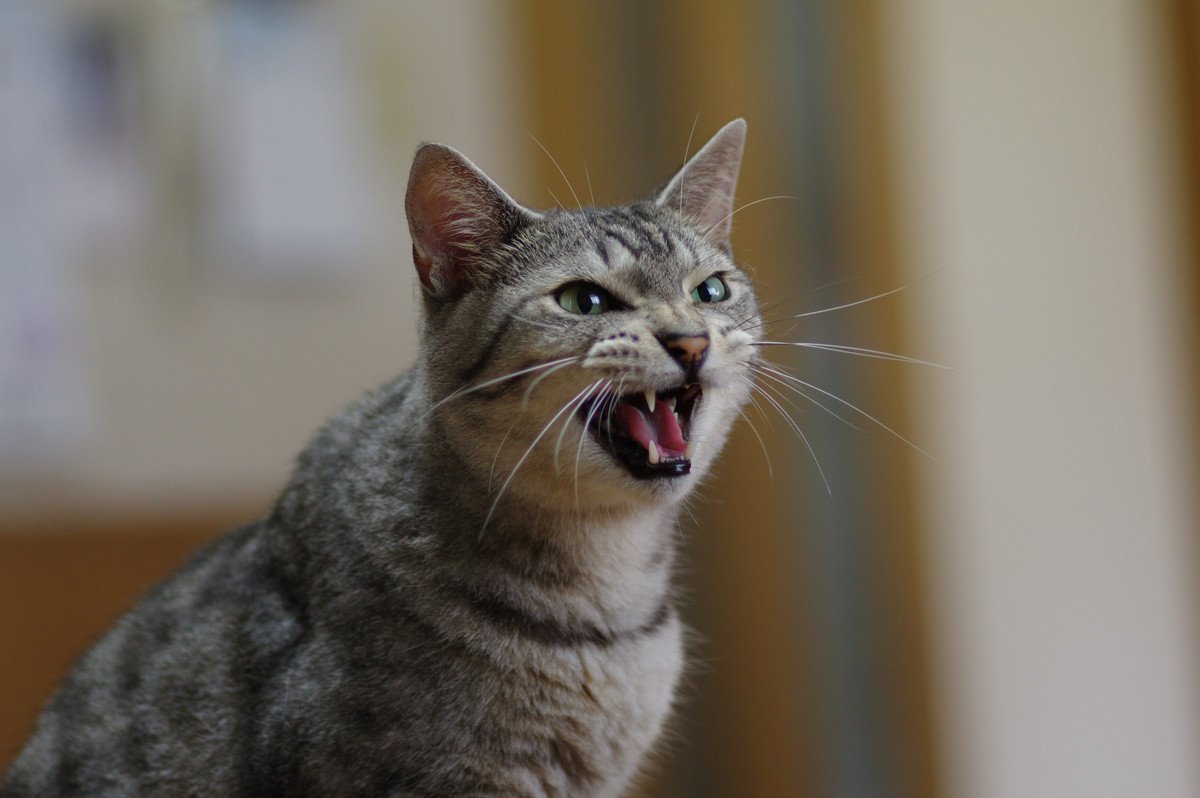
404,144,536,298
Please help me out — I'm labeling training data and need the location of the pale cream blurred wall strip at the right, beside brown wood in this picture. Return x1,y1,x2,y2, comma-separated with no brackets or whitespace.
884,0,1200,798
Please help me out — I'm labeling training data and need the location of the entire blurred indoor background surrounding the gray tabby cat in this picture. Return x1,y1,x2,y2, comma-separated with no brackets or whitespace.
0,0,1200,798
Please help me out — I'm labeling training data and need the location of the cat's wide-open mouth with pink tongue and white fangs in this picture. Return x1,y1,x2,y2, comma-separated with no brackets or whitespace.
578,383,703,479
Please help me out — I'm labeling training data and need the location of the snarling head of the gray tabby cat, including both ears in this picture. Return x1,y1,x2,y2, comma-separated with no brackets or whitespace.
406,120,758,510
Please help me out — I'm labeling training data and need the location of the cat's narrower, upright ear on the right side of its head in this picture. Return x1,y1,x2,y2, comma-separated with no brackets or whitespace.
655,119,746,251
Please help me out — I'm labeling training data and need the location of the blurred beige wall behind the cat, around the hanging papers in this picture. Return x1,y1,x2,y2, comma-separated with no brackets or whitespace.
0,1,529,517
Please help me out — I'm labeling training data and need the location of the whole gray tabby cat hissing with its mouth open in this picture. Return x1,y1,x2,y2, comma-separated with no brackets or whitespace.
4,120,758,798
